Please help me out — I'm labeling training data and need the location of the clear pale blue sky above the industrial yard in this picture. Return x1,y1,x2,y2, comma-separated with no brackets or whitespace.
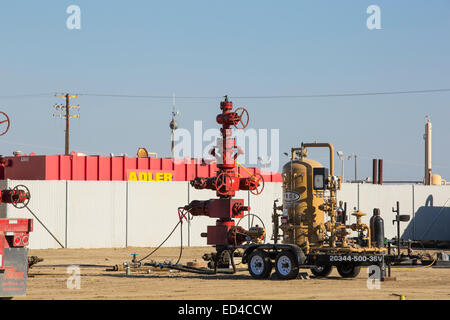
0,0,450,180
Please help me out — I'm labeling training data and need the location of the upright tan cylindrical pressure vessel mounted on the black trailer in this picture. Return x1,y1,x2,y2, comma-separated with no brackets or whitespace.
280,158,325,246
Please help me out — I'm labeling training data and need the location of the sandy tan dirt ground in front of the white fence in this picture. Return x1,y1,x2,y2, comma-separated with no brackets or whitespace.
15,247,450,300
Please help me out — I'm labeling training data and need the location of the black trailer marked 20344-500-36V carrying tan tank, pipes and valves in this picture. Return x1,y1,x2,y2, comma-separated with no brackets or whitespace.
242,143,387,279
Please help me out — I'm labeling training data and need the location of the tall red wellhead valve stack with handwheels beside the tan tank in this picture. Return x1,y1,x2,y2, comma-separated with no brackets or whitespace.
183,96,265,252
